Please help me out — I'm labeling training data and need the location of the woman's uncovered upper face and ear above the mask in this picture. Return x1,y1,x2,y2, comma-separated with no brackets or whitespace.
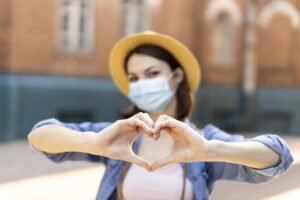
127,54,183,91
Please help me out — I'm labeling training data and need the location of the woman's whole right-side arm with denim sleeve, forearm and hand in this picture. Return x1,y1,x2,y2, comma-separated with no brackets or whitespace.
151,115,293,183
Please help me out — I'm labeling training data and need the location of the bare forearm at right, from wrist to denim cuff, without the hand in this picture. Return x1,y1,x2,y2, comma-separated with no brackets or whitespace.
209,140,280,169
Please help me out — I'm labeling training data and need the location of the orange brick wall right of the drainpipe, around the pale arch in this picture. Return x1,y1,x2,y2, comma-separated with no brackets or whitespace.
256,0,300,87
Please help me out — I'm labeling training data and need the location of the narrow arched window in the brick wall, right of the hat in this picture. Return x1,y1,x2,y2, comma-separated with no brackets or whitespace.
212,13,235,67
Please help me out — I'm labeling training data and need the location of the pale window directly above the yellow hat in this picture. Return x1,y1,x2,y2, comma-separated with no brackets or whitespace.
122,0,149,36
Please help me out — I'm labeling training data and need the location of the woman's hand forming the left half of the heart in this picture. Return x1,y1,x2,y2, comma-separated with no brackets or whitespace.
96,113,153,170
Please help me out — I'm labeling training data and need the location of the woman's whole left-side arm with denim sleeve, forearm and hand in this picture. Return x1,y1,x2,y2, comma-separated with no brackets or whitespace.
28,113,156,169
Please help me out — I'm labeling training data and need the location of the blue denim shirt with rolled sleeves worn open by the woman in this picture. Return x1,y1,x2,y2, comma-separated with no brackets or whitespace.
30,118,293,200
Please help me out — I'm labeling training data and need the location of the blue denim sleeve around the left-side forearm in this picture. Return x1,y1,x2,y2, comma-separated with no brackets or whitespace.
28,118,110,164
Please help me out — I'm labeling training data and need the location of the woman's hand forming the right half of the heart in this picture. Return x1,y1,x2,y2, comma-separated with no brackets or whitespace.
150,115,210,171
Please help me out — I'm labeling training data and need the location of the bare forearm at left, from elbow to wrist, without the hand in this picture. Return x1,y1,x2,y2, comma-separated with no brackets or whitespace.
28,124,97,153
